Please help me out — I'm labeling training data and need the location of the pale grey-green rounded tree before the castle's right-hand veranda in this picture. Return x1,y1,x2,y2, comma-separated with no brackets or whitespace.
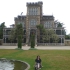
43,29,58,43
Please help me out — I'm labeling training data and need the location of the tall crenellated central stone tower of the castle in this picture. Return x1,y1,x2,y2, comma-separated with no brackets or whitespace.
26,2,43,43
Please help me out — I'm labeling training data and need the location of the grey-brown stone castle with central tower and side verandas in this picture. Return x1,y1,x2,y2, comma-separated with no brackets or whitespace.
3,1,65,45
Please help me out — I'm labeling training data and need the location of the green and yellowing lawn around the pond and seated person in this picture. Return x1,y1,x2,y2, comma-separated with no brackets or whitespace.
0,49,70,70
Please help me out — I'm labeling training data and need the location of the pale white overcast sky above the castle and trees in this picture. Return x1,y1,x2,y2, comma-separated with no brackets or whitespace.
0,0,70,34
